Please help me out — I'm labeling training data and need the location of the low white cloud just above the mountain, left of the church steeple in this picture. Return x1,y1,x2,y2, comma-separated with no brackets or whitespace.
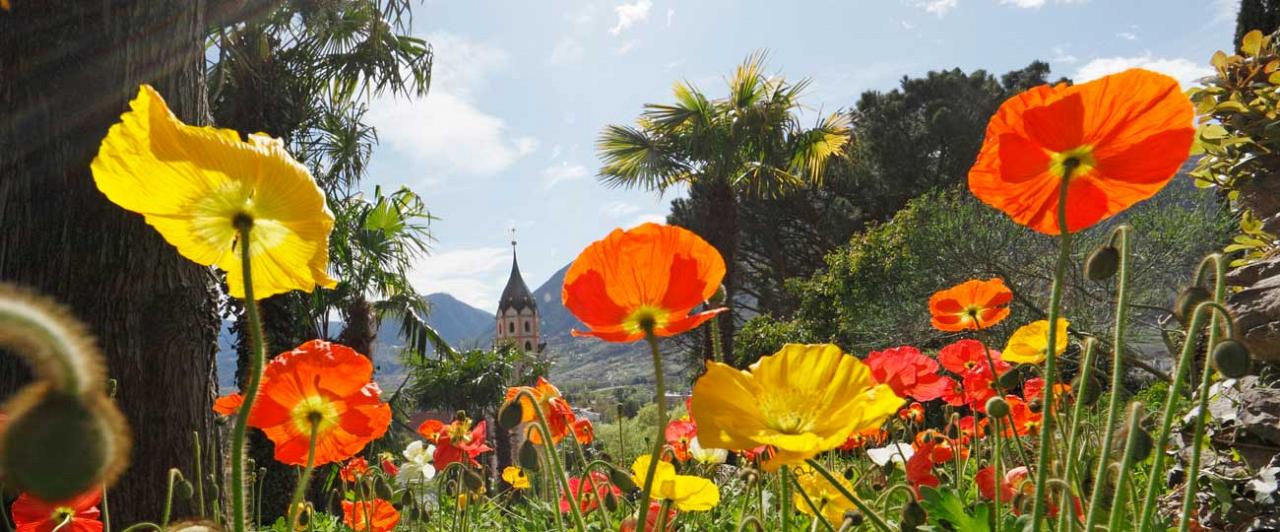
410,247,511,309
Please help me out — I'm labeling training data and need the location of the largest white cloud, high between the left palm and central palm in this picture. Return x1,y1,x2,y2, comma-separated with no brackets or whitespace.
369,33,538,182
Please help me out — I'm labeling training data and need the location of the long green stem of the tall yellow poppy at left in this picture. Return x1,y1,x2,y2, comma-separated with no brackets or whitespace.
232,219,266,532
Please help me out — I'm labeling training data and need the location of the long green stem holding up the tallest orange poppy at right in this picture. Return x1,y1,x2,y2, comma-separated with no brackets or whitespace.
1032,163,1078,532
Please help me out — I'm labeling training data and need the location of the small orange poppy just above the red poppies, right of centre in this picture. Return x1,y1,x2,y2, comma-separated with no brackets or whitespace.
929,278,1014,333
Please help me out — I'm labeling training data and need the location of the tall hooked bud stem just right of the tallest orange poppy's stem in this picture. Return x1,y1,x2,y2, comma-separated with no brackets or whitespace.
1084,225,1133,531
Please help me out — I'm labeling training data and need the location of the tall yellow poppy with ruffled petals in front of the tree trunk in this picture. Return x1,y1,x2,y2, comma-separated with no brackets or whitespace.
92,84,337,299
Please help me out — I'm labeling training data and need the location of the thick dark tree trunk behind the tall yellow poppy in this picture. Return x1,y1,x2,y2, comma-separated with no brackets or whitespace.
0,0,219,528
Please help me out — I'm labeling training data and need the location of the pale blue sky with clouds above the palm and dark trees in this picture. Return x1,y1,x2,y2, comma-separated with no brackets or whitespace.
369,0,1238,311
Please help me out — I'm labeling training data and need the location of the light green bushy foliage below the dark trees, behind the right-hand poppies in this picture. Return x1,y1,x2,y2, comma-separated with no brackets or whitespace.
790,179,1229,365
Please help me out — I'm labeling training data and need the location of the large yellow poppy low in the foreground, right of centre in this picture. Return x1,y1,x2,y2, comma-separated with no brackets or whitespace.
692,344,905,471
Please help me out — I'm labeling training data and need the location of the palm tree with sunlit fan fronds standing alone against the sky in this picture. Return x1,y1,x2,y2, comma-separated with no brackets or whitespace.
596,52,850,357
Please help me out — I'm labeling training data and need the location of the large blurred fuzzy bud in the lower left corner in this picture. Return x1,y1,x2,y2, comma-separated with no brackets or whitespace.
0,384,129,500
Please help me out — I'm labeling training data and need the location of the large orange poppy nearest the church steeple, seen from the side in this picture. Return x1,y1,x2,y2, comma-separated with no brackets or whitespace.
561,224,726,341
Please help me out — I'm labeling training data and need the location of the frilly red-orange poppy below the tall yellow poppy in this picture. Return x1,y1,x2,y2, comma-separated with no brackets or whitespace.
248,340,392,466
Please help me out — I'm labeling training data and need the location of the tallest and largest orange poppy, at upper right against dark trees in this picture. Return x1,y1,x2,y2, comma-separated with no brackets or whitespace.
969,69,1196,234
